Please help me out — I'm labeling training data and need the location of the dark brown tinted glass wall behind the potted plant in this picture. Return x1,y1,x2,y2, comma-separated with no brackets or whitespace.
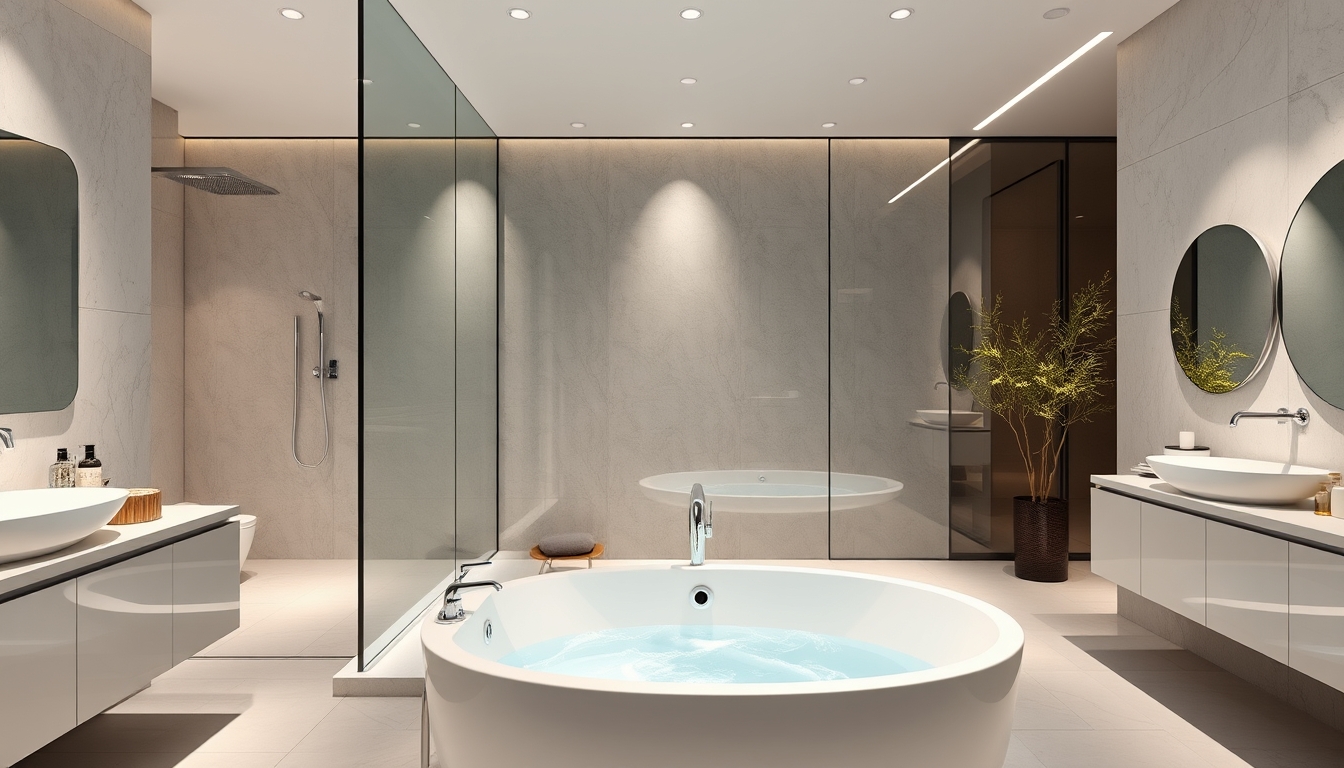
950,140,1116,557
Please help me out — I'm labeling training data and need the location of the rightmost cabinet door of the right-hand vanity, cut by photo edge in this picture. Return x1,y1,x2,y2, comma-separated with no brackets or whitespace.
1288,543,1344,691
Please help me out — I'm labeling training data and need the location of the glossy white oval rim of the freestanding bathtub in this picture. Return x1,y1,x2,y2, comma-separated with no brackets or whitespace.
421,562,1025,697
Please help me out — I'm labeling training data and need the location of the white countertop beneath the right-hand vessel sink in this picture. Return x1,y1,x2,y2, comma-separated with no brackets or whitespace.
1091,475,1344,551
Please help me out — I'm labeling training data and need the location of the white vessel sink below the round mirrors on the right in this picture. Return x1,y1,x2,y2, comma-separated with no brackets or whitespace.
1148,456,1329,504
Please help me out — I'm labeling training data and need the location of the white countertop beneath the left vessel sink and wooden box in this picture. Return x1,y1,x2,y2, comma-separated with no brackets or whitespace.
0,504,238,601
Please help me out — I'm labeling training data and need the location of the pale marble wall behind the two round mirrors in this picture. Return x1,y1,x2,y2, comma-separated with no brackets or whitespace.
1117,0,1344,478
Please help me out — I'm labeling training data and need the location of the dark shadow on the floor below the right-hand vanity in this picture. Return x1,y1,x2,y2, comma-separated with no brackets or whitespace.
1068,638,1344,768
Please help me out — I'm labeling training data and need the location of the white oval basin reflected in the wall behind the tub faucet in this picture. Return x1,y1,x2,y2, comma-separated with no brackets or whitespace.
640,469,905,512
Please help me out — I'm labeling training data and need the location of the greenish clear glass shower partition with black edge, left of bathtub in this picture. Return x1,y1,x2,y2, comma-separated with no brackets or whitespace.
359,0,499,667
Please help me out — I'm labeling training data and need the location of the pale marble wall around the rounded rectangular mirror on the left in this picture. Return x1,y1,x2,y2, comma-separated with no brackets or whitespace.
0,0,151,488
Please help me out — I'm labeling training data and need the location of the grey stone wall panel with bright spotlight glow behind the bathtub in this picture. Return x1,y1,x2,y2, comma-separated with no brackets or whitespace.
500,140,828,558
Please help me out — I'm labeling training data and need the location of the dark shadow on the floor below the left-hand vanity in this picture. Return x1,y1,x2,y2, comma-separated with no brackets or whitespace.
13,714,238,768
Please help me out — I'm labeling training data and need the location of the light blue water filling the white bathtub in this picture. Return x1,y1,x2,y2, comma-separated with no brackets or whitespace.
500,624,931,683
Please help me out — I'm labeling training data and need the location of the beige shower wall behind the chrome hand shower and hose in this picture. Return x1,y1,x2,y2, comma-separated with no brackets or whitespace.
184,140,359,558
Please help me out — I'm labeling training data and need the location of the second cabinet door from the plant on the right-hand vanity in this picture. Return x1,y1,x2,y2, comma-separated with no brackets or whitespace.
1138,503,1206,624
